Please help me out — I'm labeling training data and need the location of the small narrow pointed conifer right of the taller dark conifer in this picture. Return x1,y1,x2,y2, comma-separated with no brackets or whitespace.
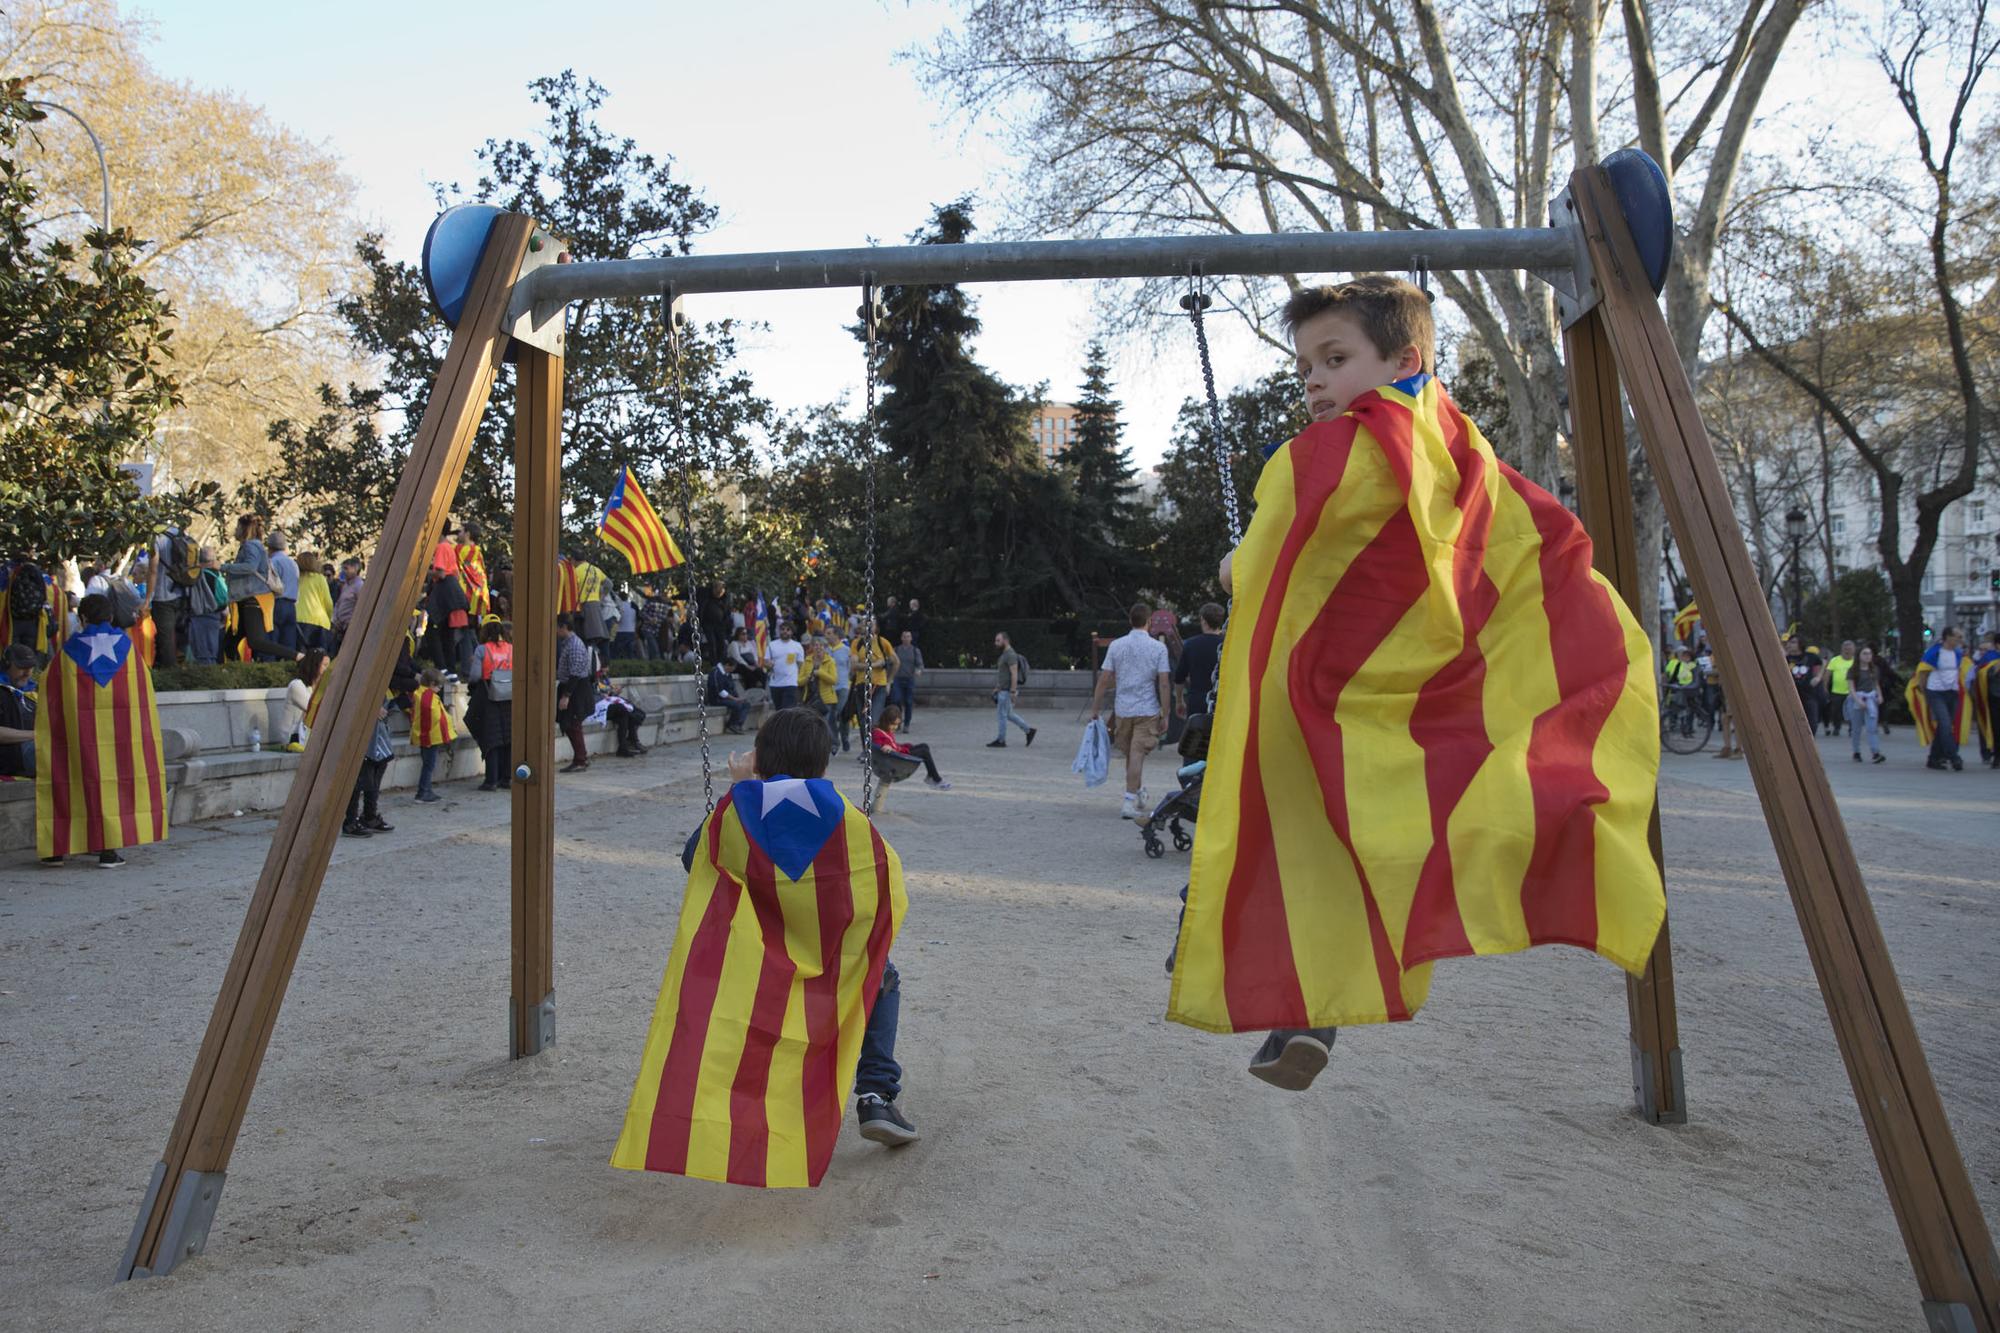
1060,340,1146,608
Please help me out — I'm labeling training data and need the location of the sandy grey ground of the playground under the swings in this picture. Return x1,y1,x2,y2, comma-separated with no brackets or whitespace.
0,711,2000,1329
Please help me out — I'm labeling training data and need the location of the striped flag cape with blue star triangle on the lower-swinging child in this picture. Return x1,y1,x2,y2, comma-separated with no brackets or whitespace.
612,779,908,1187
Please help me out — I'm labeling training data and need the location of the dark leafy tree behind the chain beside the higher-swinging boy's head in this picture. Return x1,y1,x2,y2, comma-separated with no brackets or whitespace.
1152,370,1306,610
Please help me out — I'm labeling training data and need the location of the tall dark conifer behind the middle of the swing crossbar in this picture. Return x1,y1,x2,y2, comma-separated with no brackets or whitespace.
876,200,1088,616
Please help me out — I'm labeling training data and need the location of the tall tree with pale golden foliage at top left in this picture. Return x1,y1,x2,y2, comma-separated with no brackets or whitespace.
0,0,362,498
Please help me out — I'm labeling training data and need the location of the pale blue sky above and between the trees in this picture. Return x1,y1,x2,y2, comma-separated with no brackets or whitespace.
134,0,1270,462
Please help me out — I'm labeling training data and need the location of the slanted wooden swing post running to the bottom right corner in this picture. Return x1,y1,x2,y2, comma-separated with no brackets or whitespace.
1570,166,2000,1333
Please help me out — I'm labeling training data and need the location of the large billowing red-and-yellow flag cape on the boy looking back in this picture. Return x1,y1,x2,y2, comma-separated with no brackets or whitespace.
1168,376,1666,1031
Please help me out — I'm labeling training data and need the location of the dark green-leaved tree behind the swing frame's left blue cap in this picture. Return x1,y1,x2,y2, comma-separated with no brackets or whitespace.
244,72,770,578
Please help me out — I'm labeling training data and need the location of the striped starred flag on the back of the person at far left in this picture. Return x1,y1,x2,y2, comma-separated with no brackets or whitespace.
34,624,166,857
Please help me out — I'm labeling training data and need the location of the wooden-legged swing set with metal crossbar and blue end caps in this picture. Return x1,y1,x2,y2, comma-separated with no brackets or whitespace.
118,150,2000,1333
